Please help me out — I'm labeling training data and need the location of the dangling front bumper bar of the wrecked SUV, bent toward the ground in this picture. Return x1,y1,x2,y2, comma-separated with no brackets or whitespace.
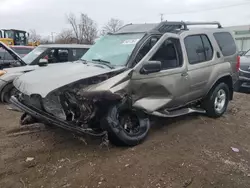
10,96,106,136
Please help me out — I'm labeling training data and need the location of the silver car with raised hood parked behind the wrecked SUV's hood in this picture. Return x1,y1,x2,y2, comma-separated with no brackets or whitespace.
0,43,90,102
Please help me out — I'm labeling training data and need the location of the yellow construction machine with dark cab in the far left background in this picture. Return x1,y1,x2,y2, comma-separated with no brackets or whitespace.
0,29,40,46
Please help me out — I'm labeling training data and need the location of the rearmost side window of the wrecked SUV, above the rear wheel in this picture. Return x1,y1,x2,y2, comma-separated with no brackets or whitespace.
214,32,236,56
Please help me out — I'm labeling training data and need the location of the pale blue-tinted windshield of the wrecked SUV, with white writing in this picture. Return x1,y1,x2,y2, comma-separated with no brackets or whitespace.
81,33,144,66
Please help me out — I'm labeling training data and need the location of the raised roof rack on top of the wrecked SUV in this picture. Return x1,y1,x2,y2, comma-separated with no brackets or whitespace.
155,21,222,33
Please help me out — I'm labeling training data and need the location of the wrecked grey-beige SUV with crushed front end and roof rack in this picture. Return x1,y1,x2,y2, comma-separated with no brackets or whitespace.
11,22,239,146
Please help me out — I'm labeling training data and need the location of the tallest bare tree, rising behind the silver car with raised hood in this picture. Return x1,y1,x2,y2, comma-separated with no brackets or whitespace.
67,13,97,44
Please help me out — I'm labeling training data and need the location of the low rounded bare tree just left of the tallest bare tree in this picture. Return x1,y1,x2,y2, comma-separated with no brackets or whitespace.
55,29,74,44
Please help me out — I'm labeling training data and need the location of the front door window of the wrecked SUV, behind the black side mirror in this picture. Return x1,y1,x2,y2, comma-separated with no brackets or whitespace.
150,38,183,70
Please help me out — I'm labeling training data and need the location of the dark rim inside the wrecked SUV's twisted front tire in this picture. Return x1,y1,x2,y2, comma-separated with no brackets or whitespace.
119,112,140,135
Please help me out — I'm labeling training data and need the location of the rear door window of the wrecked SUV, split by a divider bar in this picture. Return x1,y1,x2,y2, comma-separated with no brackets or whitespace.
184,35,213,64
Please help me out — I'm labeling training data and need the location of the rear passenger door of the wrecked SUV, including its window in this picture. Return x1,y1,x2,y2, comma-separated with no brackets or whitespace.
184,34,218,101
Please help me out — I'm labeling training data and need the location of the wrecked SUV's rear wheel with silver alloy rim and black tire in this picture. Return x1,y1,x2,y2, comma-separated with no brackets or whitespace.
204,83,229,118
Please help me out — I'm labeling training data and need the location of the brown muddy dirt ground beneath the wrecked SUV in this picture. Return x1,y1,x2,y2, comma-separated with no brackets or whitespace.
0,93,250,188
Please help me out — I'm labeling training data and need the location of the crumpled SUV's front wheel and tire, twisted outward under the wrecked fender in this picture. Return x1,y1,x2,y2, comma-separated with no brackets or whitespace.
101,103,150,146
